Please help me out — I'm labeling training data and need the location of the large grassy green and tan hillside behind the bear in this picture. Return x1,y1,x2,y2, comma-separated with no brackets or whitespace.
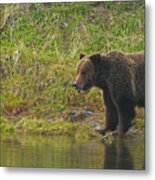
0,1,144,134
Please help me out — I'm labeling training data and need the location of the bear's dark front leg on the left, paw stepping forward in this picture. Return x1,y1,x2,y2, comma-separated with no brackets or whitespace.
100,90,118,135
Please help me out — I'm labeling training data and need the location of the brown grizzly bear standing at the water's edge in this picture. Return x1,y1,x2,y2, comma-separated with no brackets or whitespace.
73,51,145,135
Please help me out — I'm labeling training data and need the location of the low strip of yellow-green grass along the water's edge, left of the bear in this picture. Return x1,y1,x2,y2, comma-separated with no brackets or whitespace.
0,117,101,141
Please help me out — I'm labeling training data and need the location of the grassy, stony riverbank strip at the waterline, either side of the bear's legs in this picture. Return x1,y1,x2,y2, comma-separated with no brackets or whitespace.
0,105,145,141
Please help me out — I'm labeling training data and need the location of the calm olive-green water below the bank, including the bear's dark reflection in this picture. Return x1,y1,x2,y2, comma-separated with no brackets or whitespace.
1,134,145,170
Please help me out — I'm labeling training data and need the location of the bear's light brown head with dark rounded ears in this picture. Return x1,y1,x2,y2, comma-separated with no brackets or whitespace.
72,54,101,91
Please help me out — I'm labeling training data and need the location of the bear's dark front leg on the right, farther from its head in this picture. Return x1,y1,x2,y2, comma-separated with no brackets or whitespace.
117,98,135,135
